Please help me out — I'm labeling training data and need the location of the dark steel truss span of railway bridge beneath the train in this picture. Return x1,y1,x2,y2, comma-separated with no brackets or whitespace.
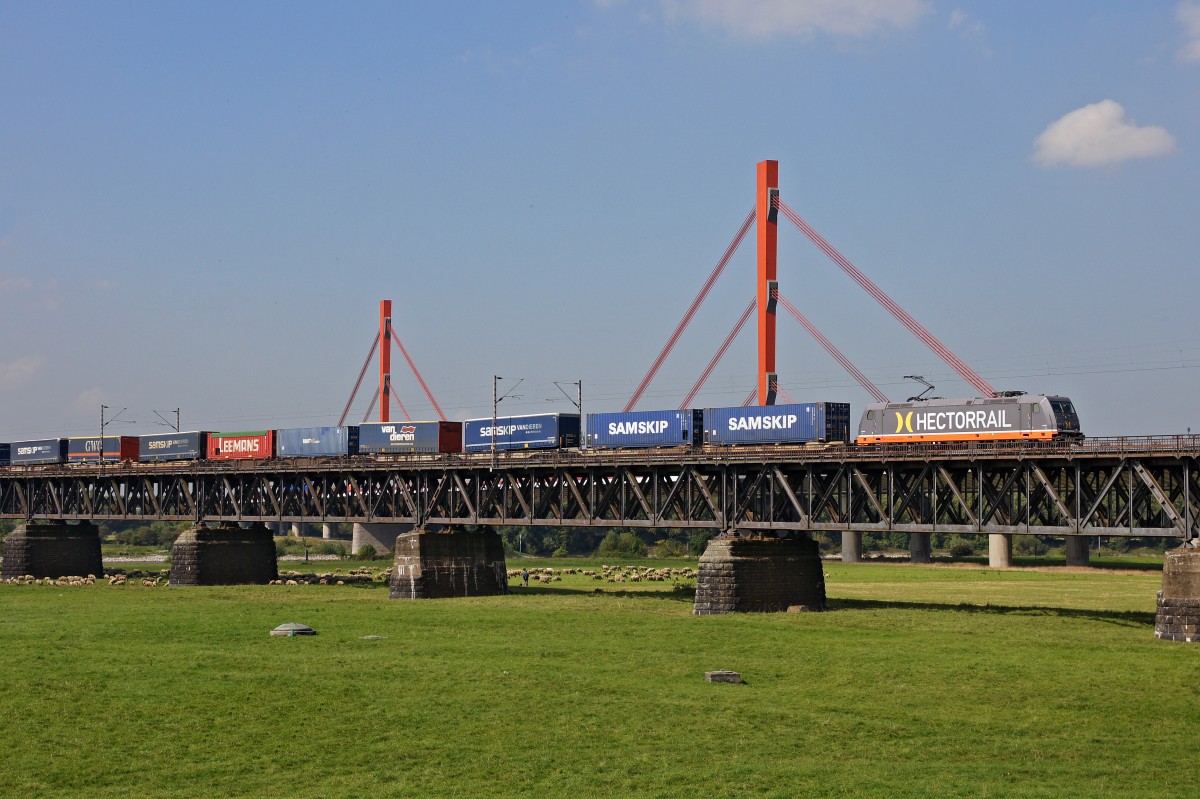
0,435,1200,540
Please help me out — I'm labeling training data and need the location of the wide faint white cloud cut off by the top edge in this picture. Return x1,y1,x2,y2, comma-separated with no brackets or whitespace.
661,0,930,38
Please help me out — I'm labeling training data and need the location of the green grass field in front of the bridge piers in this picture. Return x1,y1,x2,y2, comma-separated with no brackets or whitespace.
0,561,1200,799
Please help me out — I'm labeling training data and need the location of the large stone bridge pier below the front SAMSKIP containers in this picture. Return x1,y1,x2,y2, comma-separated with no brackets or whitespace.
695,535,826,615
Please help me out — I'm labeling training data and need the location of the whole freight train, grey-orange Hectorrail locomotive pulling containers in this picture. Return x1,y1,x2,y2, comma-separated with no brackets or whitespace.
0,395,1084,465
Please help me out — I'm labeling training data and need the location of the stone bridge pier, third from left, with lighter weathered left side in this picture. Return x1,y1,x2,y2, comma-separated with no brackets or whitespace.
390,527,509,599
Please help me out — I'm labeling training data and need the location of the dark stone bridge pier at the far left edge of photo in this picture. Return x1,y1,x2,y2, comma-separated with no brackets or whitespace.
2,519,104,579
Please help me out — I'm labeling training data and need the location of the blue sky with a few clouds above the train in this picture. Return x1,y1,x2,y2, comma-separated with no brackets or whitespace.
0,0,1200,441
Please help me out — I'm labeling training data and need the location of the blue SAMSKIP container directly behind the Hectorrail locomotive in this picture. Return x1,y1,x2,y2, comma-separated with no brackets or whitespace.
704,402,850,444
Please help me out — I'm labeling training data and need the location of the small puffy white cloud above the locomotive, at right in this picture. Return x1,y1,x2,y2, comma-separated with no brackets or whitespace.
1033,100,1175,167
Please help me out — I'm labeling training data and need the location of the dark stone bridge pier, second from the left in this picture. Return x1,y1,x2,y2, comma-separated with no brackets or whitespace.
170,522,280,585
